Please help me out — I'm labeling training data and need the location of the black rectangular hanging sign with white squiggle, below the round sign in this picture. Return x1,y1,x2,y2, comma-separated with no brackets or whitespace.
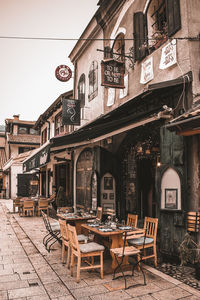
62,98,80,125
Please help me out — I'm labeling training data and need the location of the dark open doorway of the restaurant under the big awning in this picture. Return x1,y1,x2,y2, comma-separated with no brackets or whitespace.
137,157,156,219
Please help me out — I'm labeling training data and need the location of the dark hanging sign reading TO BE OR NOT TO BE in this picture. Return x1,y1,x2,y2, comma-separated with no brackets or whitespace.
101,59,124,89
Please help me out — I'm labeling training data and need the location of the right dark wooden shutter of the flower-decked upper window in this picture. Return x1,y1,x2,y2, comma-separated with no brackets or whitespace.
165,0,181,36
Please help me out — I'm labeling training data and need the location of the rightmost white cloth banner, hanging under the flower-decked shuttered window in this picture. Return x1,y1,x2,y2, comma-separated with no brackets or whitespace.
159,39,177,70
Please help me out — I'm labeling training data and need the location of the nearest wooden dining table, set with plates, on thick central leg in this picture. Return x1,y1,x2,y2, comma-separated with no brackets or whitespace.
81,221,144,273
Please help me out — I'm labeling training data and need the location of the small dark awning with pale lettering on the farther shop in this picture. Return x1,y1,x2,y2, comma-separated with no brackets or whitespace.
23,141,50,172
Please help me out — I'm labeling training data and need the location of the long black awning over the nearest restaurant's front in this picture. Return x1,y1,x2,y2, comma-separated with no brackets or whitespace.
51,72,192,151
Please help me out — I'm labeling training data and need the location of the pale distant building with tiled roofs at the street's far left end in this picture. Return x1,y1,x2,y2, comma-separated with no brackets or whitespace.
3,115,40,198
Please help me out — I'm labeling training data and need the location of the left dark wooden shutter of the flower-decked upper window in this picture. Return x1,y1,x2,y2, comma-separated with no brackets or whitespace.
133,11,146,60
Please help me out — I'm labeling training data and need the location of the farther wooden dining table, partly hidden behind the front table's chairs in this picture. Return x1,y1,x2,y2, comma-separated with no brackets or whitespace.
57,212,96,234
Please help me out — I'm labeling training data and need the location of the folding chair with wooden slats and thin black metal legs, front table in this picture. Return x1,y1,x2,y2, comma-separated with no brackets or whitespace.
110,231,146,289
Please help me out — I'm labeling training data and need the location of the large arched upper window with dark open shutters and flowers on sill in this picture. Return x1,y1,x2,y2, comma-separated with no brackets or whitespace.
133,0,181,60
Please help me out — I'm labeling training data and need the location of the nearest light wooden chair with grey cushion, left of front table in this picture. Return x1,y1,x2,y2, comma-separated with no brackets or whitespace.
67,224,105,282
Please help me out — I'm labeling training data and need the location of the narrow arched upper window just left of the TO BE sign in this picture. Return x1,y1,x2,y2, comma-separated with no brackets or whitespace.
88,61,98,101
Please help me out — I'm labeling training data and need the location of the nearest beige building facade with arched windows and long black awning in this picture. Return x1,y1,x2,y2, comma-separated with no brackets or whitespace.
51,0,200,256
